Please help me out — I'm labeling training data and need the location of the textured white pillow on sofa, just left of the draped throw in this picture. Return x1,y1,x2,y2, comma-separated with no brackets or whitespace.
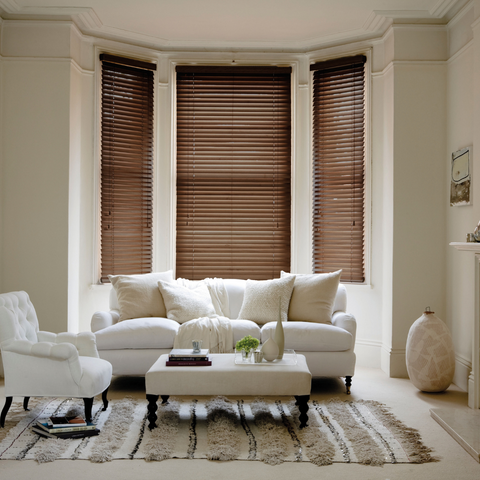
158,280,215,323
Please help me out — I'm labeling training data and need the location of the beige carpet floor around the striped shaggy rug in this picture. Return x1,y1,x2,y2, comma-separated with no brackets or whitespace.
0,368,480,480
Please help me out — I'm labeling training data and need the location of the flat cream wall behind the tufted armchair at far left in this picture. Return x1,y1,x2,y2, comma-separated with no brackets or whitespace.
1,54,70,330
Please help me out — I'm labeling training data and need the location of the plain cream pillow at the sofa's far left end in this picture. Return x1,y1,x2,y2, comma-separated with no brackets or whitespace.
108,270,173,321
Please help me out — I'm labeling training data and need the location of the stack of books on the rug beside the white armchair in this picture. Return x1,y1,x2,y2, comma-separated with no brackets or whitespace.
32,416,100,438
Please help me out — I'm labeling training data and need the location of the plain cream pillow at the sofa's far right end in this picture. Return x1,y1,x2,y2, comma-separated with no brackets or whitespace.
282,270,342,323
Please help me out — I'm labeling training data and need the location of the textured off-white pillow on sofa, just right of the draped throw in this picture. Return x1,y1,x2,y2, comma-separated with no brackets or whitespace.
238,277,295,325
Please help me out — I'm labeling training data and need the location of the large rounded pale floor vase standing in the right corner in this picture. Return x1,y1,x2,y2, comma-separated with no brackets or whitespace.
406,308,455,392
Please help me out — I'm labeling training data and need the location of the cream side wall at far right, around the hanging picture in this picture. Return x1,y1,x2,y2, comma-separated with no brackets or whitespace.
444,2,480,390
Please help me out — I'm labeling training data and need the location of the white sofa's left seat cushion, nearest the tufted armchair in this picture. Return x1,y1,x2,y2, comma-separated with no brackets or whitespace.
95,317,180,350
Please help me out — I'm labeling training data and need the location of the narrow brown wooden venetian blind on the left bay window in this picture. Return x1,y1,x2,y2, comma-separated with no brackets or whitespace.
100,54,155,282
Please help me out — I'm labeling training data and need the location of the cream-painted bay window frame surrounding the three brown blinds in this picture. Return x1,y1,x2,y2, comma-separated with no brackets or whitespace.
92,54,372,291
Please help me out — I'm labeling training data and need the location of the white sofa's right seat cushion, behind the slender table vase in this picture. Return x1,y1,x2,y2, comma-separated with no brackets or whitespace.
262,322,353,352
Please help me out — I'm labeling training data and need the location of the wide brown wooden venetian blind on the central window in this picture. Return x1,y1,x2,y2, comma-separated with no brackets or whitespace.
176,66,291,280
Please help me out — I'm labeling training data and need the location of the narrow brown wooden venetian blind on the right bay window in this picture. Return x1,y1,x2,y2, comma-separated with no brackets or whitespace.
311,55,366,282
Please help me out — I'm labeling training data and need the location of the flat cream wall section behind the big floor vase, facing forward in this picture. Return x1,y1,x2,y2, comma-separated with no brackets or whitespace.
391,64,446,376
